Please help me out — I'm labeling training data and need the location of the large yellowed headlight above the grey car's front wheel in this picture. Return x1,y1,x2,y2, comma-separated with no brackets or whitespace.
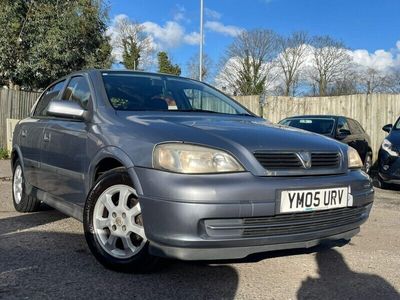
153,143,244,174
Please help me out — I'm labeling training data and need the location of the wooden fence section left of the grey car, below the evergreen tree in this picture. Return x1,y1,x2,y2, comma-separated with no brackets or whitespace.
0,88,39,148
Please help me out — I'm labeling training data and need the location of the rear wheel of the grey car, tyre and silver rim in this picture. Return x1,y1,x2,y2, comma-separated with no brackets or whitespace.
12,159,40,213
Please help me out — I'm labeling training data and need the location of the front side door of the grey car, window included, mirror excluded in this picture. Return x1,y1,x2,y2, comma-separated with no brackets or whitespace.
42,76,92,204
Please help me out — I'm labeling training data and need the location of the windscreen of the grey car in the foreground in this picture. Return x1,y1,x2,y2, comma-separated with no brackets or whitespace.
103,72,251,115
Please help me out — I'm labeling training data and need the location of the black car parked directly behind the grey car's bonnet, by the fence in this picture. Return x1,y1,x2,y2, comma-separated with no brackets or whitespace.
279,115,372,173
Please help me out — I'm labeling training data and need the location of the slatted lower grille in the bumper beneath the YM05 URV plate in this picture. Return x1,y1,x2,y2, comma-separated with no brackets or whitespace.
205,207,367,237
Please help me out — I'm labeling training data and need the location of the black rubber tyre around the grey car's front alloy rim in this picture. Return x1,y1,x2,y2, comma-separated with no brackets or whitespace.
83,169,156,273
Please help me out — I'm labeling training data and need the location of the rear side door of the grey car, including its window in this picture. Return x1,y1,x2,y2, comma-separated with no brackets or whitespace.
19,80,65,189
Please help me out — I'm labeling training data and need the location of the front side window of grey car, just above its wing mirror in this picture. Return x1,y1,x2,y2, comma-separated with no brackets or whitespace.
63,76,91,109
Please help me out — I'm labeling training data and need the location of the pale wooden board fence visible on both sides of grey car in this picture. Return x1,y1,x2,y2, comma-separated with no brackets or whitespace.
0,88,400,158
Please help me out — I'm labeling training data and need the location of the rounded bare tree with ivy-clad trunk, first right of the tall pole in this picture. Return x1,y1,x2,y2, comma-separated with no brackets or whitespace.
216,29,277,95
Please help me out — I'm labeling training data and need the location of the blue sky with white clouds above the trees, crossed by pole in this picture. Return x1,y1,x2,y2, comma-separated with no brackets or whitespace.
110,0,400,75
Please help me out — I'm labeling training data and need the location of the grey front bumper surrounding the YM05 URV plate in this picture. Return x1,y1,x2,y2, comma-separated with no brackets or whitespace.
134,168,374,260
